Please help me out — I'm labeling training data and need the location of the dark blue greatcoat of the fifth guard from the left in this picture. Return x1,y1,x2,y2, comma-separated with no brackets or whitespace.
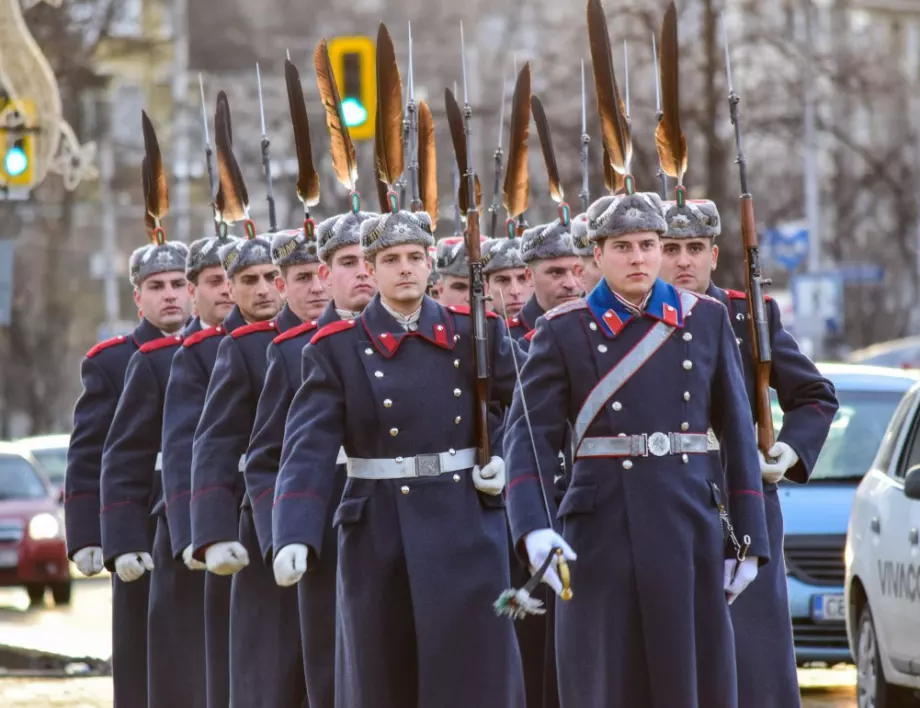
245,303,345,708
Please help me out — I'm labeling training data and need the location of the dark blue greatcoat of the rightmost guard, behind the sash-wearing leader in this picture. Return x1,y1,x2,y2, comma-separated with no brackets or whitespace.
707,285,838,708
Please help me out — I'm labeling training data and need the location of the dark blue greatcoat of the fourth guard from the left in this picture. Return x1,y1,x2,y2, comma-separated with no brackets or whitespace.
191,307,306,708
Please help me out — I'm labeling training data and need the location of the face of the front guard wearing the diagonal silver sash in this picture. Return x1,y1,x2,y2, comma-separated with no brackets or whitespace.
594,231,661,301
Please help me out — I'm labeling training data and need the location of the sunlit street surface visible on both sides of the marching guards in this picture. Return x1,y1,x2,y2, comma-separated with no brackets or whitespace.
0,577,856,708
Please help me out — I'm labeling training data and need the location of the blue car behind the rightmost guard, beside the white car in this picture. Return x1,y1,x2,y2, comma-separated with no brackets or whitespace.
773,364,920,665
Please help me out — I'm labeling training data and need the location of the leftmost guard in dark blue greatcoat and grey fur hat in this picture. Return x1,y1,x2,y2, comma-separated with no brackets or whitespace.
65,239,190,708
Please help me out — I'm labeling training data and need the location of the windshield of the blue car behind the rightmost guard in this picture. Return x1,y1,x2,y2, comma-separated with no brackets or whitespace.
771,390,904,482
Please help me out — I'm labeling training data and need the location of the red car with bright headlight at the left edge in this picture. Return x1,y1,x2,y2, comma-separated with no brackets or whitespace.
0,443,71,605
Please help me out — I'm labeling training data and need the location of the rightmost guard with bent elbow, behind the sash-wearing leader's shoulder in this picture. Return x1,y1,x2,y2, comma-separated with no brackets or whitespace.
661,200,838,708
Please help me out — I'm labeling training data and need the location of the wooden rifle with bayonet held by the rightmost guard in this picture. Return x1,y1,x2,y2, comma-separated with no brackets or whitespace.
721,16,776,458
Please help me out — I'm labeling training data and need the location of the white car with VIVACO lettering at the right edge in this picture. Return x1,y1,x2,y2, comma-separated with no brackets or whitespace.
844,384,920,708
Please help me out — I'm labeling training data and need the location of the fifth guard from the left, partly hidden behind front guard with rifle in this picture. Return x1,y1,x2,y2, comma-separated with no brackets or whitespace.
245,212,374,708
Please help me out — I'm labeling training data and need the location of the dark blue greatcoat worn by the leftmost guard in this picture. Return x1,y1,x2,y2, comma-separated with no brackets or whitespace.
64,319,163,708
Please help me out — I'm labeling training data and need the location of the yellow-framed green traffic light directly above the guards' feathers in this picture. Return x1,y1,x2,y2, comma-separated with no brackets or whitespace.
327,37,377,140
